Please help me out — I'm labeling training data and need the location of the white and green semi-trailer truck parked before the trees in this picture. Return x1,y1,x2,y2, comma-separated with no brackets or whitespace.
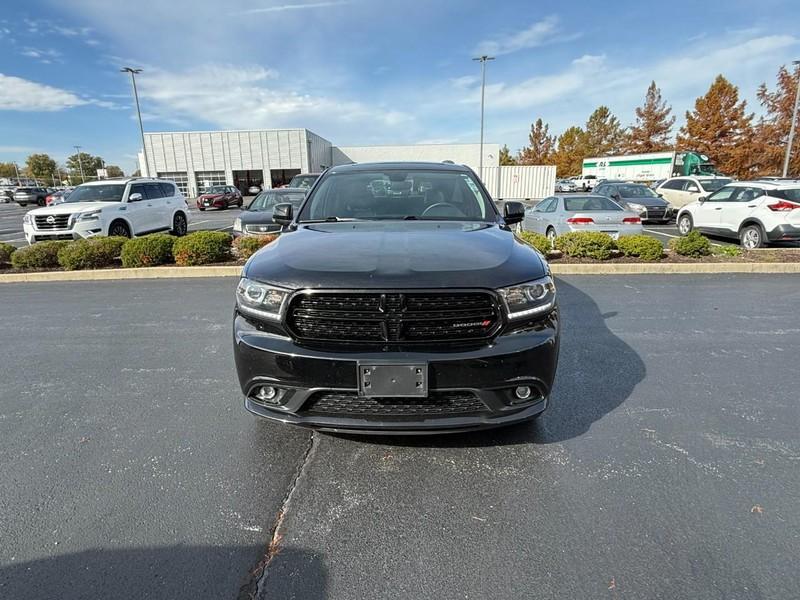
582,151,720,182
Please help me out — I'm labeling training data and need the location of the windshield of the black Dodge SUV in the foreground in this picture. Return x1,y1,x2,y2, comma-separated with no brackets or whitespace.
298,169,497,222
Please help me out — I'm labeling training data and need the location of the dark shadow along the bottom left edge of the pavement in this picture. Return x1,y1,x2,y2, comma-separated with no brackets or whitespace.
0,545,327,600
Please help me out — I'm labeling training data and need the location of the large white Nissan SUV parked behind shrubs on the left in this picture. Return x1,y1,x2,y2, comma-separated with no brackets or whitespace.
22,177,189,244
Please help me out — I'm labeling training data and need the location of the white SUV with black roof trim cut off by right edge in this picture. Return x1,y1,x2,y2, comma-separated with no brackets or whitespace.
676,181,800,249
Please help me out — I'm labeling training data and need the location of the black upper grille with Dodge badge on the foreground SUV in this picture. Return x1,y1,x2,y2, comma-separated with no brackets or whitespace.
287,292,500,343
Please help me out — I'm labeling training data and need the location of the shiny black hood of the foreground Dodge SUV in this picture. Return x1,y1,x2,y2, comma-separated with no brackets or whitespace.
243,221,547,289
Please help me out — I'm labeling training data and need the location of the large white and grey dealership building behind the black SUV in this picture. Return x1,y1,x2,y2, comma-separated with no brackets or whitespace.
139,129,500,197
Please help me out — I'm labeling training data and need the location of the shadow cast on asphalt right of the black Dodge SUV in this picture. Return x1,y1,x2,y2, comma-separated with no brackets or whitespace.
334,280,646,448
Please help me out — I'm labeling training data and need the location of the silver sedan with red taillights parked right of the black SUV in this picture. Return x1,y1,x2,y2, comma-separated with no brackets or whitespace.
522,194,642,241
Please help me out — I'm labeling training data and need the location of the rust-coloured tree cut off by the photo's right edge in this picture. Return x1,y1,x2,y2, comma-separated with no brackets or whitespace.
754,65,800,177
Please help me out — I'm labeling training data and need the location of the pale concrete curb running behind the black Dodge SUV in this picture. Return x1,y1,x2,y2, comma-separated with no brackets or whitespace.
0,263,800,284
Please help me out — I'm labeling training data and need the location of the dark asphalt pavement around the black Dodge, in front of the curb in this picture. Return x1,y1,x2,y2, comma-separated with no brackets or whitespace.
0,276,800,600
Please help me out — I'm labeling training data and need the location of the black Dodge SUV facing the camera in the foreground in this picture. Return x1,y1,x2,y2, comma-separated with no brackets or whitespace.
233,163,559,433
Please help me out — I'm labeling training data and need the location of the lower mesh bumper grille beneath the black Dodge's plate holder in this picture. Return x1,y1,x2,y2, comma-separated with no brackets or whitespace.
301,391,488,418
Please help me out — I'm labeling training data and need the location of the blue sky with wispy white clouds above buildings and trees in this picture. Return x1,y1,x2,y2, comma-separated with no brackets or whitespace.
0,0,800,172
